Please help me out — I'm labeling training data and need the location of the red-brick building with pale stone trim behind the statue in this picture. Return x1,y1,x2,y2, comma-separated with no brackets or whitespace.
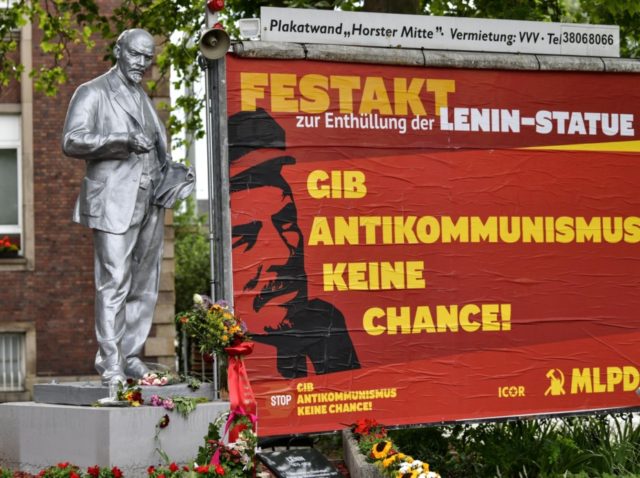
0,9,175,402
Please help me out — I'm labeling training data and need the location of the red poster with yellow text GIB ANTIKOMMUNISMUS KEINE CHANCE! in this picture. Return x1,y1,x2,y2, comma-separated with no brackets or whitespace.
227,56,640,436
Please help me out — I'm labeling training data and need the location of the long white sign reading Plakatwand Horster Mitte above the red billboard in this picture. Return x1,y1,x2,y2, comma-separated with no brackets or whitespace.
260,7,620,57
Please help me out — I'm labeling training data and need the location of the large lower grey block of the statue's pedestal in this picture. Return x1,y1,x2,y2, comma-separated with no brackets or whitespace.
0,401,229,478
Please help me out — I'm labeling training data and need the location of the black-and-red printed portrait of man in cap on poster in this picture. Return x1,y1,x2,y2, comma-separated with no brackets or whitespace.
228,109,360,378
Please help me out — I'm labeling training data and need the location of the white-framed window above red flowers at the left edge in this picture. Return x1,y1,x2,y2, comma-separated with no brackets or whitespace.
0,114,23,259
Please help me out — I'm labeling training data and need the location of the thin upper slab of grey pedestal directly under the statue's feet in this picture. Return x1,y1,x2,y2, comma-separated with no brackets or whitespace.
33,382,215,405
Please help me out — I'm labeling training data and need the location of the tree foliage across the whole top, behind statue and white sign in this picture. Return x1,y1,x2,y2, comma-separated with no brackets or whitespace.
0,0,640,162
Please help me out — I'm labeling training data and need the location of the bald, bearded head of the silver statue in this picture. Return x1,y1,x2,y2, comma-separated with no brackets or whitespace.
113,28,155,84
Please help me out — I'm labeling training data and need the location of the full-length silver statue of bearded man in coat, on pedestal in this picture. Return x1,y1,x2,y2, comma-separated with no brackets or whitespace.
62,29,194,384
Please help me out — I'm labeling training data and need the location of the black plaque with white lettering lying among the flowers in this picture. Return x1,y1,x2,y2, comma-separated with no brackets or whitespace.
258,448,342,478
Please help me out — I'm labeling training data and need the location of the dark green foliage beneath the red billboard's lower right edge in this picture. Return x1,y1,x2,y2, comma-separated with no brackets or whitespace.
390,414,640,478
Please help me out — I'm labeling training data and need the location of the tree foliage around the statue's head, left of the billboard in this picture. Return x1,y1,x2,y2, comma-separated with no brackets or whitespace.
0,0,205,155
